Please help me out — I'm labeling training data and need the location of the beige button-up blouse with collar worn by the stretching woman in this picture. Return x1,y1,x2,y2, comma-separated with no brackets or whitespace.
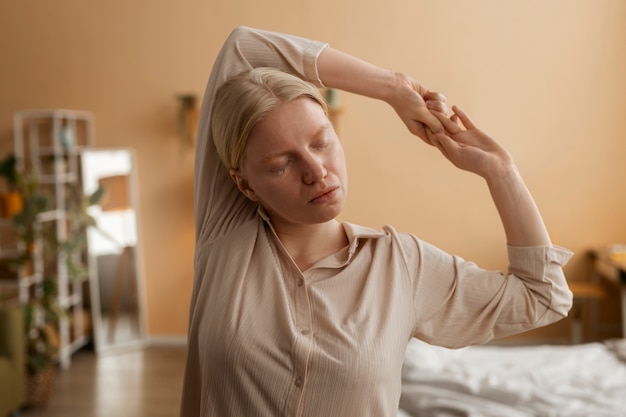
181,27,572,417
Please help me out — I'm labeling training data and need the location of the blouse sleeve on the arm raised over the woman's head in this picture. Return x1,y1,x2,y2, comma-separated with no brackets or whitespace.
194,27,327,245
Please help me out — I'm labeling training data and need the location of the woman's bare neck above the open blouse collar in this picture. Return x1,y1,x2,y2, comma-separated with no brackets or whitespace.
275,220,348,271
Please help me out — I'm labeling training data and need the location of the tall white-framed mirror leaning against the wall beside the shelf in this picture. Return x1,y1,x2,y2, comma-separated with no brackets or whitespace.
81,149,145,353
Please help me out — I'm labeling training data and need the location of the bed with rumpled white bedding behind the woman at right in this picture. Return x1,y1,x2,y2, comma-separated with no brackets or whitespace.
398,339,626,417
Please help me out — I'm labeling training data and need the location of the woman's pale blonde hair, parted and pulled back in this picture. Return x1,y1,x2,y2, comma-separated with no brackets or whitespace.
211,68,328,169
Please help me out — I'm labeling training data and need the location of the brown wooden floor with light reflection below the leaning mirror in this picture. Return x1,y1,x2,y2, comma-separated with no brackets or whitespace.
21,347,186,417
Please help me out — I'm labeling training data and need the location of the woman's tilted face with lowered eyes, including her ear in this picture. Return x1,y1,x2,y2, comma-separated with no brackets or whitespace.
231,97,348,227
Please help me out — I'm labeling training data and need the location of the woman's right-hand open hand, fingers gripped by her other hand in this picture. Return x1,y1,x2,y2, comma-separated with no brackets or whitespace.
426,106,515,180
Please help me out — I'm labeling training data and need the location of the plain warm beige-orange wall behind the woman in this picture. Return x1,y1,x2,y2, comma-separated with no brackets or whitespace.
0,0,626,337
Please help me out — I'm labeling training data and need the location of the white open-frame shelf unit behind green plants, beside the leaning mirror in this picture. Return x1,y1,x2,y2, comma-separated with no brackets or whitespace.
13,109,94,367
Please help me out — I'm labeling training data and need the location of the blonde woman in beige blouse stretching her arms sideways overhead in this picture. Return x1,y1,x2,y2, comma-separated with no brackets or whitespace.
181,27,571,417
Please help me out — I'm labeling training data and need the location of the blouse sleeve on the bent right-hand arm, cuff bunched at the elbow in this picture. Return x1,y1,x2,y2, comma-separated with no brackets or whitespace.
406,234,572,348
